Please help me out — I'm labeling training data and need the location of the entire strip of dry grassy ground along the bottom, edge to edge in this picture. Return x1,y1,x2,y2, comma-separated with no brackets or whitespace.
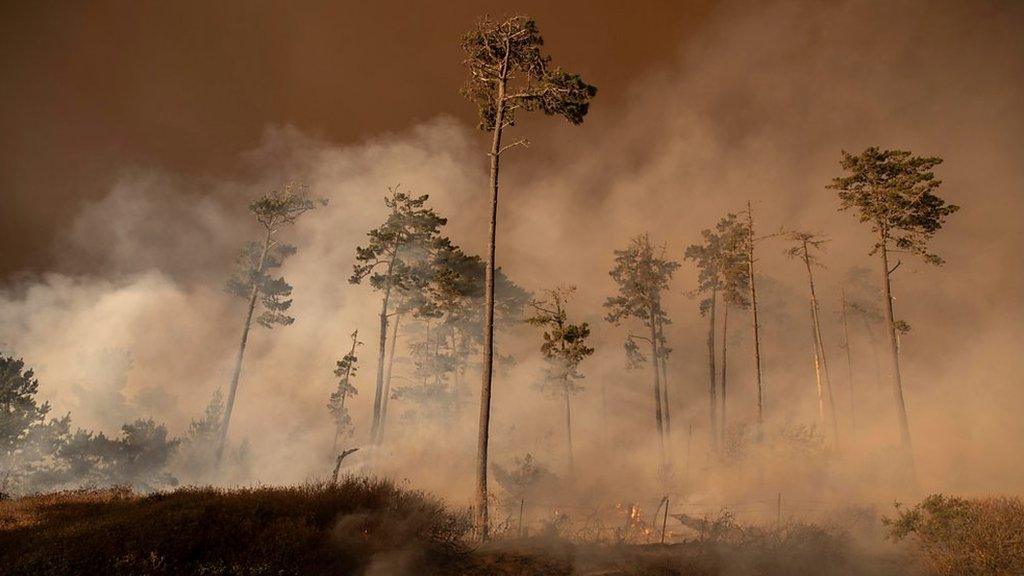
0,479,1024,576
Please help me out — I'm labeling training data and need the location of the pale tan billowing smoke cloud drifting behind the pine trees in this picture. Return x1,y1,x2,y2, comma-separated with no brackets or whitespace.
0,1,1024,510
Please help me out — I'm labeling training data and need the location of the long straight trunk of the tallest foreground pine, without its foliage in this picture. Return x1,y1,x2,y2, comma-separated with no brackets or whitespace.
474,65,508,540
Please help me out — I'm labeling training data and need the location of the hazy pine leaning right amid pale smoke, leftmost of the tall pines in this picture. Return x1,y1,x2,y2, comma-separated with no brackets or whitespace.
216,186,327,461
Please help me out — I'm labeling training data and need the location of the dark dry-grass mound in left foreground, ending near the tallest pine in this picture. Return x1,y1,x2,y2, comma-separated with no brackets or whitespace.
0,479,468,576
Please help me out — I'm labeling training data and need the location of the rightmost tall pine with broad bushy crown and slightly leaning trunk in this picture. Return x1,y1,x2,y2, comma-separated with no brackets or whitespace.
826,147,959,465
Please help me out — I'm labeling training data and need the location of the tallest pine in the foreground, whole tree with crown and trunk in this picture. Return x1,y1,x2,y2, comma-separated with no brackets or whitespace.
461,15,597,540
